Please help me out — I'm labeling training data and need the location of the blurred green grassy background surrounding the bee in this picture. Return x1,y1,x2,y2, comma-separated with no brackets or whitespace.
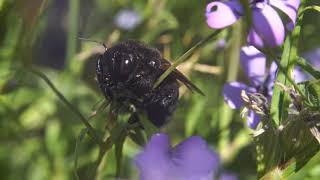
0,0,320,180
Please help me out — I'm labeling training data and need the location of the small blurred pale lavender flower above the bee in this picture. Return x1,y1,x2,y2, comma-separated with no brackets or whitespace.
115,9,142,30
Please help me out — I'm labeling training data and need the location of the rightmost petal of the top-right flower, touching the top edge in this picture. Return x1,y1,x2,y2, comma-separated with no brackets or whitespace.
269,0,300,31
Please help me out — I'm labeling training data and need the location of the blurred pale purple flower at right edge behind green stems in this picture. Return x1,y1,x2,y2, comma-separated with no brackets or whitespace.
293,48,320,83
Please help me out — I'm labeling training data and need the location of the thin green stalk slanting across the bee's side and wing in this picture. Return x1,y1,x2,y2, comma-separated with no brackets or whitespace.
153,30,222,88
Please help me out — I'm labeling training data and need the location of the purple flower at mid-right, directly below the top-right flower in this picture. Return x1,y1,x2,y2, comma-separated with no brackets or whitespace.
223,46,277,129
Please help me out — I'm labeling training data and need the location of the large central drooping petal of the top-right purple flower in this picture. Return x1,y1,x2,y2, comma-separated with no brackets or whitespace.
252,4,285,48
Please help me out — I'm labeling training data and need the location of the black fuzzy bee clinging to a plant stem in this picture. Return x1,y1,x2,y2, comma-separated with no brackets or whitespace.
96,40,203,127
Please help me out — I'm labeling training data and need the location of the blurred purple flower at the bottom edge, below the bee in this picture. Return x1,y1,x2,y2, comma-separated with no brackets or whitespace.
135,133,219,180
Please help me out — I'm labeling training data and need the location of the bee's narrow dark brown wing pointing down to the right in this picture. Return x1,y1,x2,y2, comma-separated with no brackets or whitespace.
160,59,205,96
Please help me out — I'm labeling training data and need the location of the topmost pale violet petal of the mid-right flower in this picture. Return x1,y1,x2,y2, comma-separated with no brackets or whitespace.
240,46,267,86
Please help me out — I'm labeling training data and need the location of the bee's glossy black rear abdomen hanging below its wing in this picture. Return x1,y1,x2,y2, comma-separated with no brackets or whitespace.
144,81,179,127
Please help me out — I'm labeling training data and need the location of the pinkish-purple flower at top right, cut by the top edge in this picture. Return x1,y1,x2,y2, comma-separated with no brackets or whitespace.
206,0,300,47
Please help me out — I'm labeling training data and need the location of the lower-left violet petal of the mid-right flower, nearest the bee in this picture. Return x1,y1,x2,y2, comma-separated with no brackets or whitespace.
223,81,255,109
